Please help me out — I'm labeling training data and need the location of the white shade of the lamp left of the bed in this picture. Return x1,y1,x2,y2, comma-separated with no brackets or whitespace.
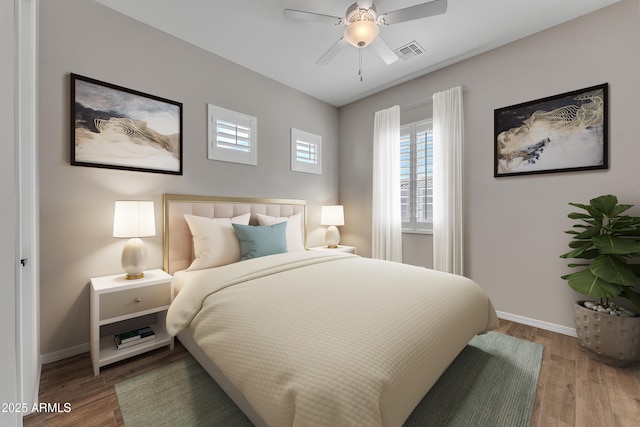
113,200,156,238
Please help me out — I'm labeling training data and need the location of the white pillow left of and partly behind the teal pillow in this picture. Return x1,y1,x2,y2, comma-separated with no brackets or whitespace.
184,214,251,270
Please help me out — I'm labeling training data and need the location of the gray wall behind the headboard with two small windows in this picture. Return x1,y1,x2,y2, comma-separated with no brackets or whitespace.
38,0,338,355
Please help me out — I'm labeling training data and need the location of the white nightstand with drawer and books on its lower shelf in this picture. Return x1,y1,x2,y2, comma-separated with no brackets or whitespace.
90,270,173,375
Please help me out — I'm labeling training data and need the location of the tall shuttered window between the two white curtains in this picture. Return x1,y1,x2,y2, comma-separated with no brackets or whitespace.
400,120,433,233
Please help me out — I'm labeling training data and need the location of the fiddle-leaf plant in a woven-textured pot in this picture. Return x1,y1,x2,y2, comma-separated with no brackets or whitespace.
561,195,640,366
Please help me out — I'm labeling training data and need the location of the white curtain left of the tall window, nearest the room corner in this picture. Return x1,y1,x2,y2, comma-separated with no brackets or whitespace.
372,105,402,262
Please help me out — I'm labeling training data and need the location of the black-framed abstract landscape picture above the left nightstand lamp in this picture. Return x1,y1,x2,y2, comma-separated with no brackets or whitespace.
70,73,183,175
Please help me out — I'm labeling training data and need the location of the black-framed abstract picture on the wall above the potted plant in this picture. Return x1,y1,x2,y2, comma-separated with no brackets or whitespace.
494,83,609,177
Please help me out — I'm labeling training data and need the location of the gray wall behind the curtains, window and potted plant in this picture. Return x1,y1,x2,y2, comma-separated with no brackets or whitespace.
339,0,640,328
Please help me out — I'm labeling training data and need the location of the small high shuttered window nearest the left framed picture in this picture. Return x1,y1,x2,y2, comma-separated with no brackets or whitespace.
207,104,258,165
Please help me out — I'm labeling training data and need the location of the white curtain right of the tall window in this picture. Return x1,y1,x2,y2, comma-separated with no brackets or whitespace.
433,86,464,275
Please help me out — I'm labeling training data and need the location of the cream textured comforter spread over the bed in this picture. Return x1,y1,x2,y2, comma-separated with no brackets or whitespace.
167,252,498,427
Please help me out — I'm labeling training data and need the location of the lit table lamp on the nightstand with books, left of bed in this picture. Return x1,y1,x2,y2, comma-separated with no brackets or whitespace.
113,200,156,280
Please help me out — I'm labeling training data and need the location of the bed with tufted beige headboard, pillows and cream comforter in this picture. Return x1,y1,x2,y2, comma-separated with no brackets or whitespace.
164,194,498,426
